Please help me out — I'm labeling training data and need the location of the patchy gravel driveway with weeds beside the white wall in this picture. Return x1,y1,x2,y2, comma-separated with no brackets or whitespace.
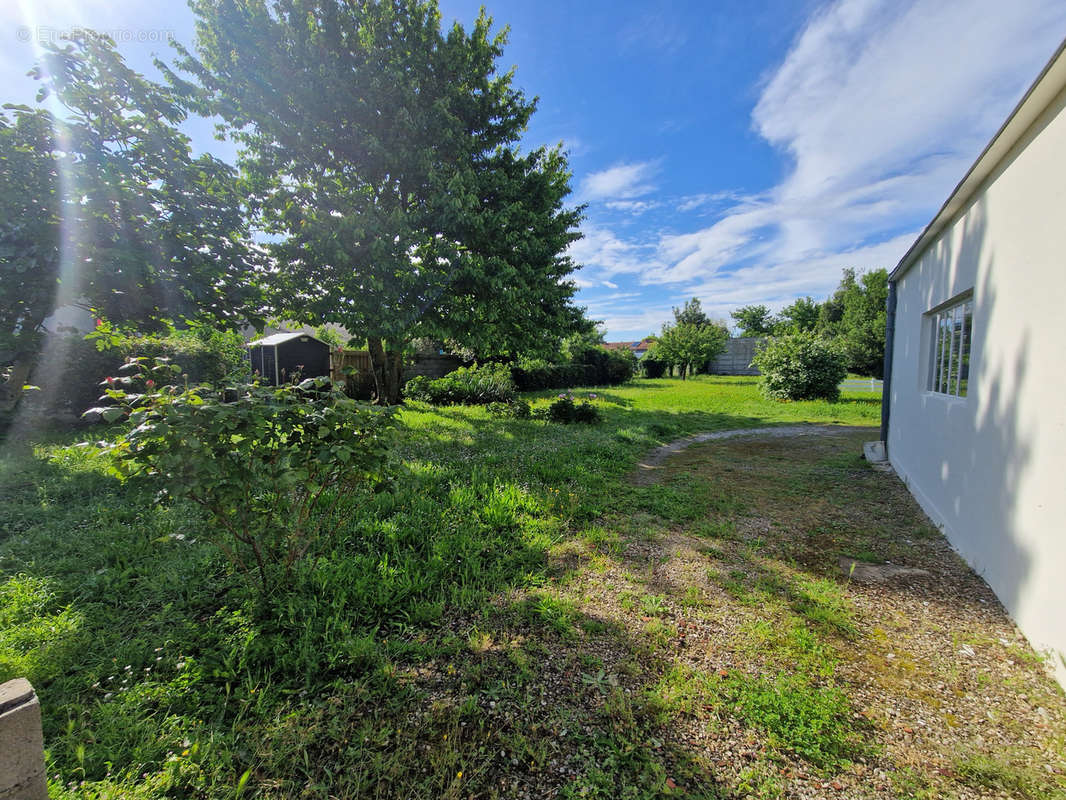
618,425,1066,800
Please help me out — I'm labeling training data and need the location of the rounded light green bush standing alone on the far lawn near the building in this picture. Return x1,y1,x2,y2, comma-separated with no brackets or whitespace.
752,333,847,401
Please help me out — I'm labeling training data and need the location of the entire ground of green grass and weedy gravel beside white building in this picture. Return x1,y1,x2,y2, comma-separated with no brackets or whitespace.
0,378,1064,798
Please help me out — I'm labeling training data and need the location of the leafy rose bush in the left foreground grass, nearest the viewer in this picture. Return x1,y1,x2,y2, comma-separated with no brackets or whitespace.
86,358,391,591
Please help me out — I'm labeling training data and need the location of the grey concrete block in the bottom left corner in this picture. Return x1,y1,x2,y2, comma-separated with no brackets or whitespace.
0,678,48,800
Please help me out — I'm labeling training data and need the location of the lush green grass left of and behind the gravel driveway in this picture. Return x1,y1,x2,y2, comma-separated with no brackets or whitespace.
0,378,879,798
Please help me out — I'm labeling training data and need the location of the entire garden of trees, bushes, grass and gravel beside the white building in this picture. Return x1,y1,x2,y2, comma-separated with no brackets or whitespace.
0,0,1066,800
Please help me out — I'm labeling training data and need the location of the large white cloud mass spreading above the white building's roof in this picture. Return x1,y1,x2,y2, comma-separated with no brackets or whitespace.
600,0,1066,327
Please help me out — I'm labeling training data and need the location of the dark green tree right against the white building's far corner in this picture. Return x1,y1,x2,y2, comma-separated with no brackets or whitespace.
818,269,888,378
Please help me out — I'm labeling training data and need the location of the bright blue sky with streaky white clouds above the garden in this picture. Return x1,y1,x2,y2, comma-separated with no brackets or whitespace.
6,0,1066,339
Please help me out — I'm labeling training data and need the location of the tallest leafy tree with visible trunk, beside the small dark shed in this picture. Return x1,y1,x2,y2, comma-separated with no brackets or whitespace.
181,0,580,402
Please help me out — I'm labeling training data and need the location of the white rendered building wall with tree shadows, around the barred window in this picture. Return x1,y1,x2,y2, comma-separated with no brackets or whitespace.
888,83,1066,686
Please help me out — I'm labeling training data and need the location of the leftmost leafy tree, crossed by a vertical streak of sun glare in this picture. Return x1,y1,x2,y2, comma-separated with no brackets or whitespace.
0,31,259,410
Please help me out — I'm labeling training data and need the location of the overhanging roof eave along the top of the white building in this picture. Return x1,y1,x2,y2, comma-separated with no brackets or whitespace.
888,41,1066,281
